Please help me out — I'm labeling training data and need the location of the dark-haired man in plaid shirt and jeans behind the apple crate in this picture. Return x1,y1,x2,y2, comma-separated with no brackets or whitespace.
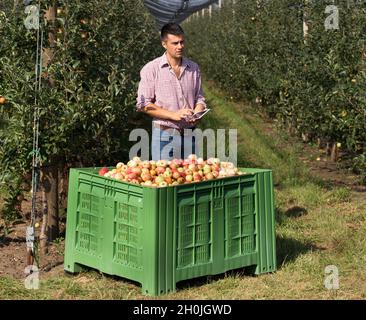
137,23,206,160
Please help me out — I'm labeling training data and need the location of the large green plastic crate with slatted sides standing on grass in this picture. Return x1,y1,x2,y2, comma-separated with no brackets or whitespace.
64,168,276,295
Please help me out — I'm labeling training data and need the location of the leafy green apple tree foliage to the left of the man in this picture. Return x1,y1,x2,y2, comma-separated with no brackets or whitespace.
0,0,161,219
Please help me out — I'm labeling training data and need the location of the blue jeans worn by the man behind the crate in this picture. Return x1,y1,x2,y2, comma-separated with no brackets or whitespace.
151,127,197,161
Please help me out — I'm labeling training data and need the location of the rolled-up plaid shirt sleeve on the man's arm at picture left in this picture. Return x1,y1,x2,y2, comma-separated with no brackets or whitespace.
136,65,155,111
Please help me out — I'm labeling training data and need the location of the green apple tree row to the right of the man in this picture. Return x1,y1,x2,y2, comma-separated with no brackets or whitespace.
184,0,366,179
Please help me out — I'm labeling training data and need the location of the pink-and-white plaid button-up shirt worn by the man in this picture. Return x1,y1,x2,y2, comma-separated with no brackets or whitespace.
137,53,206,128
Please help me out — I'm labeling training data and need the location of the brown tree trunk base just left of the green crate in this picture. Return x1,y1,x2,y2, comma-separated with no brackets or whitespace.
41,166,59,241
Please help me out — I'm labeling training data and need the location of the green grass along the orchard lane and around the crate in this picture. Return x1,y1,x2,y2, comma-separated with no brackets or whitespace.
0,80,366,300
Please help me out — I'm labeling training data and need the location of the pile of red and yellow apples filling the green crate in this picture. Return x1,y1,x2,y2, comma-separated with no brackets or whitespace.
99,154,245,187
